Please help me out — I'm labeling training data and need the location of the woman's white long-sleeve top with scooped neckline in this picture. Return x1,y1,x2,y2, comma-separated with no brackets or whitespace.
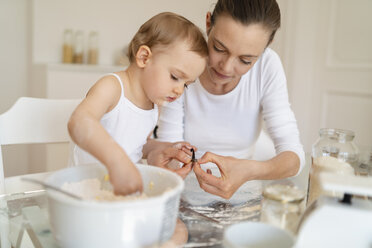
157,48,305,204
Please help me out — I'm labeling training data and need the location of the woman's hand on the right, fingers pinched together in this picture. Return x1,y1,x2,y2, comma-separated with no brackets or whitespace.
194,152,253,199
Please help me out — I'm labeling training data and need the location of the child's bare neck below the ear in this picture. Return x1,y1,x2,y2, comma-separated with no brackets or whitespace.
125,65,154,110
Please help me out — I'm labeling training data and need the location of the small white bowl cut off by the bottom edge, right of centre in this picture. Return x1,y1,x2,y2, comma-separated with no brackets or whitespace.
224,221,294,248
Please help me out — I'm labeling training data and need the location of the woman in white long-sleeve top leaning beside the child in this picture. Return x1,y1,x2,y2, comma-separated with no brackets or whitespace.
144,0,304,202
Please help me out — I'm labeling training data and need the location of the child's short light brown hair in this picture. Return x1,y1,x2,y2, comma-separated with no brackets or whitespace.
127,12,208,62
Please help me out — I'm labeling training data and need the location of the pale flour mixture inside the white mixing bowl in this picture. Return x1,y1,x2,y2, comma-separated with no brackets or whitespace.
62,178,147,201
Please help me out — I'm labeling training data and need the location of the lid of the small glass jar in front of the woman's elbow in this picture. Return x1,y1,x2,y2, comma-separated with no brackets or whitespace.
263,184,305,203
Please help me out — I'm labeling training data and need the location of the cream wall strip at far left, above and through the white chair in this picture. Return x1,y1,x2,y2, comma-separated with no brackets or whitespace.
0,0,31,175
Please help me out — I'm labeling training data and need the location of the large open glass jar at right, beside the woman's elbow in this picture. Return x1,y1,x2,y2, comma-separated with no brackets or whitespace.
307,128,359,205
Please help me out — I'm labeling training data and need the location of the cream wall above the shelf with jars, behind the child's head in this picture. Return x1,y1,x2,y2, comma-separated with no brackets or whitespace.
32,0,215,65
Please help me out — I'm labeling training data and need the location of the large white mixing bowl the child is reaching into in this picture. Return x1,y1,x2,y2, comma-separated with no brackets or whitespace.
46,164,184,248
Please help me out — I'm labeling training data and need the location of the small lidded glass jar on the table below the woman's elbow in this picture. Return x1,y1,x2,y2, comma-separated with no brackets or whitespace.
261,183,305,234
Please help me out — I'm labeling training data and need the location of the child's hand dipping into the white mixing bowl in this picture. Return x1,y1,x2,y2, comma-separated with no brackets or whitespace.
109,164,143,195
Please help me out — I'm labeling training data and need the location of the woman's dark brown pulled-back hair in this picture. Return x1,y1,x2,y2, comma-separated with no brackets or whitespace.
211,0,280,45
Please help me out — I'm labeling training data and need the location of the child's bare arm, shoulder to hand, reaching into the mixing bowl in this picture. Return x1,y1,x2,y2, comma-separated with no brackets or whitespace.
68,77,142,195
